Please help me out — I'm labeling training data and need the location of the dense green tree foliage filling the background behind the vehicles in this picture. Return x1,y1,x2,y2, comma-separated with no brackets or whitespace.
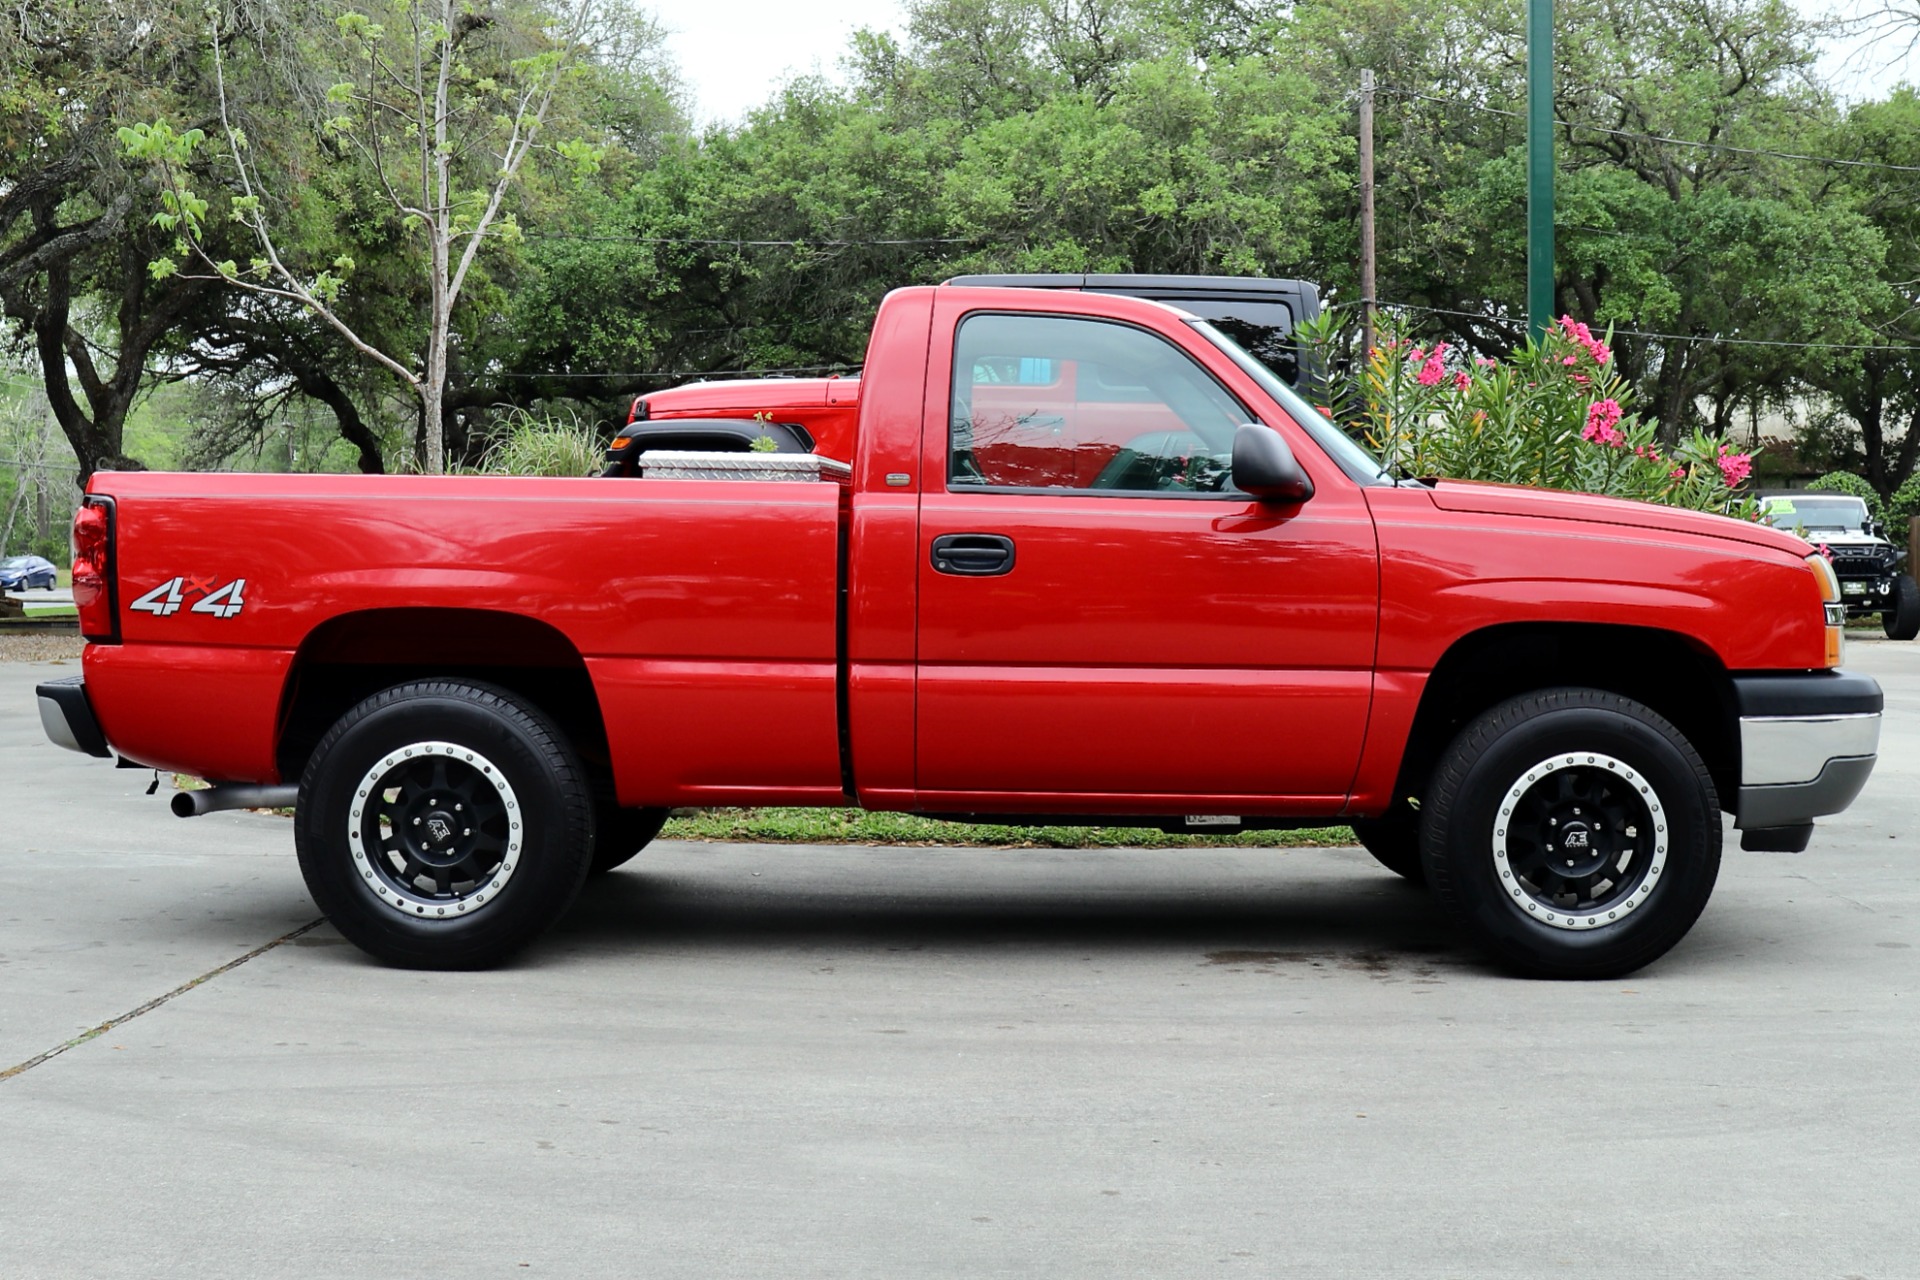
11,0,1920,501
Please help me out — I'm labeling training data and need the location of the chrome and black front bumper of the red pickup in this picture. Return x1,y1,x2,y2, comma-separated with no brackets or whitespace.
1734,672,1884,831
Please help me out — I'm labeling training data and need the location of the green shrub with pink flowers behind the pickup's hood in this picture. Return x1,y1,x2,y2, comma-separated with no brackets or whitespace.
1304,317,1755,518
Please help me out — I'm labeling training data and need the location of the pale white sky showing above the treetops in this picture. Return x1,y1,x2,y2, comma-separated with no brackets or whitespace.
659,0,1920,125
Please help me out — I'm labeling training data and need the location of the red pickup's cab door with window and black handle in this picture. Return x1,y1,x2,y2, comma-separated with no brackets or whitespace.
916,303,1379,814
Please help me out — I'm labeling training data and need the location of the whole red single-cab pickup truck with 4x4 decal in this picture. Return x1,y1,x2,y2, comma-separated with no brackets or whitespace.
38,288,1882,977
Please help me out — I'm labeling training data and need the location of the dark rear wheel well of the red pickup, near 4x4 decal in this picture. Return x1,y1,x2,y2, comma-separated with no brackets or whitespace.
275,606,611,781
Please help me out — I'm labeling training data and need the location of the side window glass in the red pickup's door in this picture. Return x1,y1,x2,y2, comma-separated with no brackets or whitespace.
947,315,1252,493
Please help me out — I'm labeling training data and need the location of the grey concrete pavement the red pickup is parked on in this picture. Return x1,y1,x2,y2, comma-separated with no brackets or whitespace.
0,643,1920,1278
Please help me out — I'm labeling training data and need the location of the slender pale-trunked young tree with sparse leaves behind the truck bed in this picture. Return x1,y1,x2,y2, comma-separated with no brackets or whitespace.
121,0,657,472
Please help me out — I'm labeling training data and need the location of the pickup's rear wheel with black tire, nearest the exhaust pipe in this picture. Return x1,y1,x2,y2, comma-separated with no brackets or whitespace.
294,681,593,969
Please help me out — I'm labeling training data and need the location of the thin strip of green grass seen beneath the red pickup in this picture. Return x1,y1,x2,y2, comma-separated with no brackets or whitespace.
660,808,1354,848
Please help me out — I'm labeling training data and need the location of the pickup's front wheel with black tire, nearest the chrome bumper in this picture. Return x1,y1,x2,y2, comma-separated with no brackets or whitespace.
1421,689,1720,979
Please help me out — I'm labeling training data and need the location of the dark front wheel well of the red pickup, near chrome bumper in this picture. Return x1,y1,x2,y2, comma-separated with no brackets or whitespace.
1394,622,1740,806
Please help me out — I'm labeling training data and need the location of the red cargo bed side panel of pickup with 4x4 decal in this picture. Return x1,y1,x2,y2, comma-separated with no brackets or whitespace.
86,474,841,804
